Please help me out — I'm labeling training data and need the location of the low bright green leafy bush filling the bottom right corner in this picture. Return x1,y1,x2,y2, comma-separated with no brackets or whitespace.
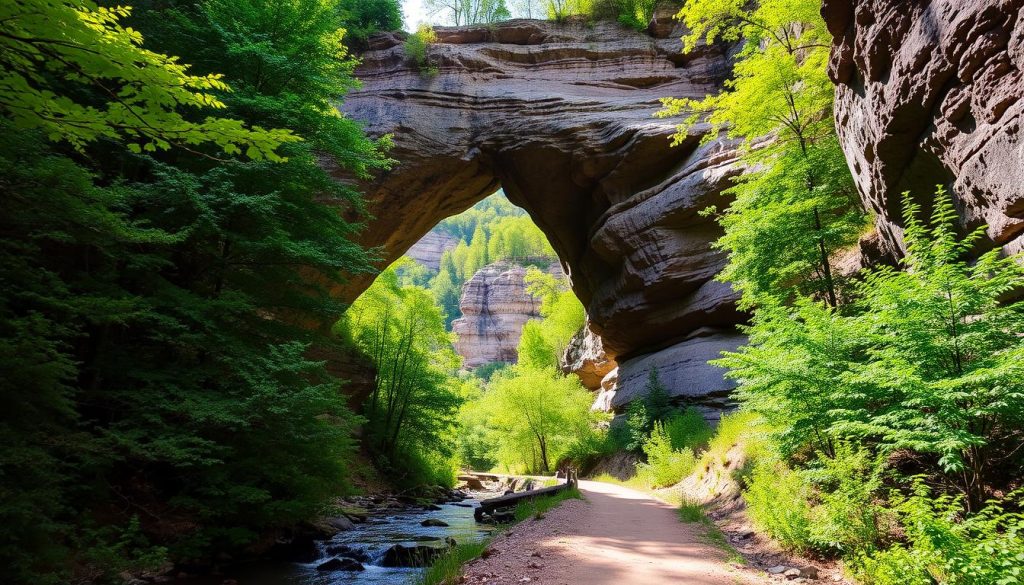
858,478,1024,585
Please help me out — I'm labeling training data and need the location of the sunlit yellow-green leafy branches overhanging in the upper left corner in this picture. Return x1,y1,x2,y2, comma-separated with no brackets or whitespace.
0,0,299,156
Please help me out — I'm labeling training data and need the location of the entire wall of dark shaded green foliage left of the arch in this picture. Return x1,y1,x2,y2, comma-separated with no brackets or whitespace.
0,0,388,583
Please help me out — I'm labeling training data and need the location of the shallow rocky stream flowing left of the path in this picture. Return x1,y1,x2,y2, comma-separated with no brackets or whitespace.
175,500,494,585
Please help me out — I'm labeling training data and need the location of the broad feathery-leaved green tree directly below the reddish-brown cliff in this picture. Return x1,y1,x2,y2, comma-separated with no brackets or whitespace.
718,191,1024,508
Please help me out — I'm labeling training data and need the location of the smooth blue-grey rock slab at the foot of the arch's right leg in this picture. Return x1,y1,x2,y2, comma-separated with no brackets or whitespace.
611,328,746,422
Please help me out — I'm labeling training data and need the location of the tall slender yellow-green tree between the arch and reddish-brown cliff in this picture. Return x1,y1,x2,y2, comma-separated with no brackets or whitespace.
658,0,865,308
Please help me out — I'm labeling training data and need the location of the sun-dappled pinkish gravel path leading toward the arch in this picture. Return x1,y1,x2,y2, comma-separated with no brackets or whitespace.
465,482,769,585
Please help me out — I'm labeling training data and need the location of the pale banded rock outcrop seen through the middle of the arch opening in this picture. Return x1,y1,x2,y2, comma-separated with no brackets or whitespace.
452,262,541,368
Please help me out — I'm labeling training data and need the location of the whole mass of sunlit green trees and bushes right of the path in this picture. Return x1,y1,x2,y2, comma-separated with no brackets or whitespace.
660,0,1024,584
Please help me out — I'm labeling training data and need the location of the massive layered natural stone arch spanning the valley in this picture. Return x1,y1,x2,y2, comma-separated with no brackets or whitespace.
343,17,743,411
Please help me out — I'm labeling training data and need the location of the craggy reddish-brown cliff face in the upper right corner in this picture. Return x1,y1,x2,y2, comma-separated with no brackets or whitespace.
822,0,1024,255
